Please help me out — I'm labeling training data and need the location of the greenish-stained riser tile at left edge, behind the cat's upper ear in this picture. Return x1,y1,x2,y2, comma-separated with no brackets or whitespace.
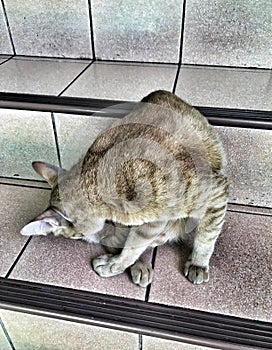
0,109,58,180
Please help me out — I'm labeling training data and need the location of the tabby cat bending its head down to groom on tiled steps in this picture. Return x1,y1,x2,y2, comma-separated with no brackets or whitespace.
21,90,228,287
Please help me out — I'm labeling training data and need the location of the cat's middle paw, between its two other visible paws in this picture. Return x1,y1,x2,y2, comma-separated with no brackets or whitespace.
130,260,154,288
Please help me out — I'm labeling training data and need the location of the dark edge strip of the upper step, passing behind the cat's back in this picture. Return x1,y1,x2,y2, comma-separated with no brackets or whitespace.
0,92,272,130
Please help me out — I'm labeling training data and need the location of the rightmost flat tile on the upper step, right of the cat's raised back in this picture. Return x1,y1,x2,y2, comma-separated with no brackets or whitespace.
176,66,272,111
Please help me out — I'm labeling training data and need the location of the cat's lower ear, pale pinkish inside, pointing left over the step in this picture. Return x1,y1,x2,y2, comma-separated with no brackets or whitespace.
20,209,61,236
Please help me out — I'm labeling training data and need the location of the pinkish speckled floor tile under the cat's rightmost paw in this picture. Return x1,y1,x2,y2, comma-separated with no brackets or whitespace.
149,213,272,322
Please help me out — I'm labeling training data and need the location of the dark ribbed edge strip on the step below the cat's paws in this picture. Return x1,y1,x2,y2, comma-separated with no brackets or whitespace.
0,278,272,349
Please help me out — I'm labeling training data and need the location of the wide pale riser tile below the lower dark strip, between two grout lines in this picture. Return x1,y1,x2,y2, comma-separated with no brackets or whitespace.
0,310,138,350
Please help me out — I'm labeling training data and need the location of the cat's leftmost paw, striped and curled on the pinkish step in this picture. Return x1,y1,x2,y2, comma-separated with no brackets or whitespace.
92,255,124,277
